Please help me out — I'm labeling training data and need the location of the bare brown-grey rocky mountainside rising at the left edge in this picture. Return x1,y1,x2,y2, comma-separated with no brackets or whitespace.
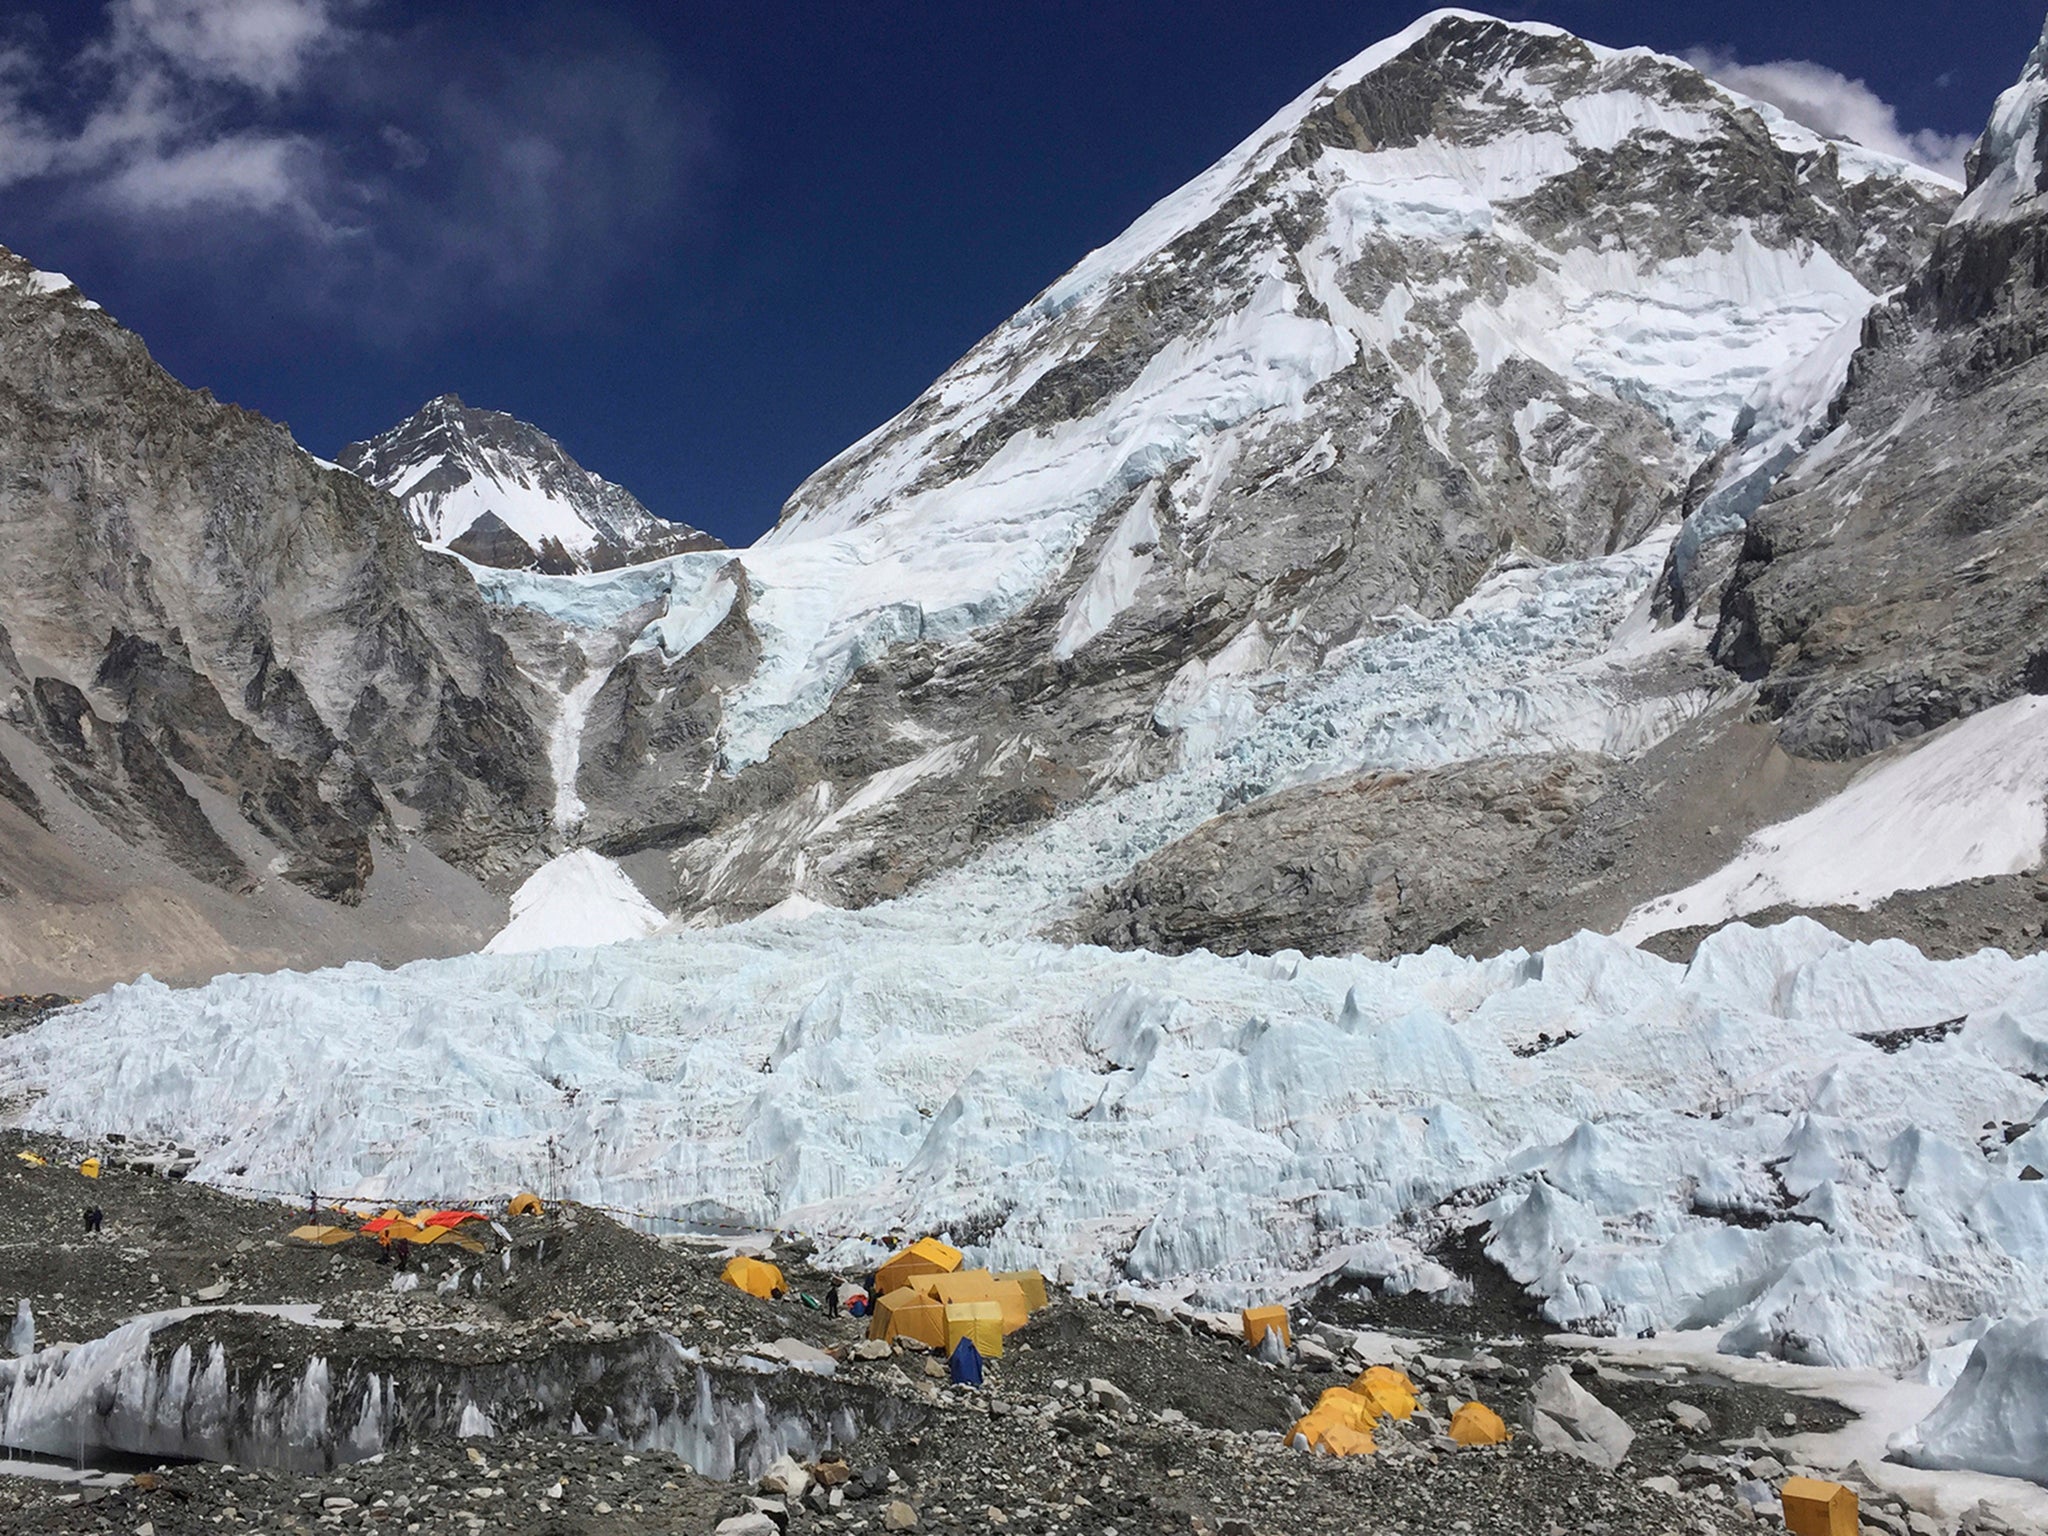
0,252,549,991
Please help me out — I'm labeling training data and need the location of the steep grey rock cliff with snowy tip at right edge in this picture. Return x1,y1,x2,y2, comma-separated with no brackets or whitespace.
1714,13,2048,758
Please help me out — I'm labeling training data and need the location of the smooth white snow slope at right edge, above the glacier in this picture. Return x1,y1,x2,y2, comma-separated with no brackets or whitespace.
1620,694,2048,942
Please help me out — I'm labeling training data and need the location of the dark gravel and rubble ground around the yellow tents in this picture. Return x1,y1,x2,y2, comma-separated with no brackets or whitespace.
0,1135,2023,1536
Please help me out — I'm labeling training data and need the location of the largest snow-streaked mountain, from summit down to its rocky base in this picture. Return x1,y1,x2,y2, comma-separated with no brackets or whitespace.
536,12,1958,918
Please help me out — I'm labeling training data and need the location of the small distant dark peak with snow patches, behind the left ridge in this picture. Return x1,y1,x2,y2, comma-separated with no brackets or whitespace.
340,393,719,573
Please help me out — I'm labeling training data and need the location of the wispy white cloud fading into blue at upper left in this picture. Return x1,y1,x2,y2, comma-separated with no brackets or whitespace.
0,0,709,338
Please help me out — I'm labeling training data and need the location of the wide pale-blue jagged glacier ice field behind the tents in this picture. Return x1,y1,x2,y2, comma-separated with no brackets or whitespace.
0,903,2048,1372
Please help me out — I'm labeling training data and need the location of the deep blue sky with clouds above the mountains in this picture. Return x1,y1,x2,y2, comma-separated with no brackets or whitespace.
0,0,2042,543
